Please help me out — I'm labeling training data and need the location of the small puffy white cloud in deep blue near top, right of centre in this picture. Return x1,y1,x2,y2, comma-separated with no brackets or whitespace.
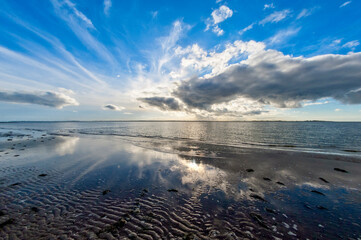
205,5,233,36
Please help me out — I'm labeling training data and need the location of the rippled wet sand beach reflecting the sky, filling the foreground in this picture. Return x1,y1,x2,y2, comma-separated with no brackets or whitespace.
0,133,361,239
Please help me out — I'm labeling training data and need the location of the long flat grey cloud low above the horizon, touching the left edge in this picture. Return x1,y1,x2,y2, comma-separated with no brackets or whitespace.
0,91,78,108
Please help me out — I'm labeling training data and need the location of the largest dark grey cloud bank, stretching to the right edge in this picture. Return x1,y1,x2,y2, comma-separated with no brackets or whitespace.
173,50,361,109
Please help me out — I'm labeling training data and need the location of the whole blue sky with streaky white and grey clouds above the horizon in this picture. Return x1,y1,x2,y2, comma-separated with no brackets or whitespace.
0,0,361,121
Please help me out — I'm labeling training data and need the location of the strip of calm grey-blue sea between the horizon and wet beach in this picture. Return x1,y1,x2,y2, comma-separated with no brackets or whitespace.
0,122,361,155
